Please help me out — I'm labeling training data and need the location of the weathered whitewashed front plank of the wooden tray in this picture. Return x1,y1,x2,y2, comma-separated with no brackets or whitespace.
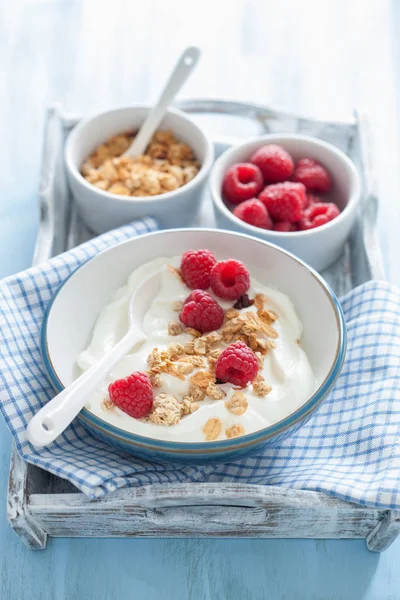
25,483,388,539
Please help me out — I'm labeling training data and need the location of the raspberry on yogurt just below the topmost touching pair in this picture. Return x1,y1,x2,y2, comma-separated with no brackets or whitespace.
179,290,224,333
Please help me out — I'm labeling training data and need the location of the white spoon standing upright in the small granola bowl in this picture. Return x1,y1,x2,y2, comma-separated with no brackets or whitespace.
124,46,200,158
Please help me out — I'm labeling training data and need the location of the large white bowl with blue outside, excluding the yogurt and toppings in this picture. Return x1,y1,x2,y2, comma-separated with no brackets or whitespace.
41,229,346,462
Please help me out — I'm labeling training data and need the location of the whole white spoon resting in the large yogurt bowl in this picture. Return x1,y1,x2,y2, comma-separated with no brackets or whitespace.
26,272,160,448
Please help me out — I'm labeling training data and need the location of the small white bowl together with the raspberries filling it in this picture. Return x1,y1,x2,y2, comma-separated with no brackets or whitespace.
210,134,361,271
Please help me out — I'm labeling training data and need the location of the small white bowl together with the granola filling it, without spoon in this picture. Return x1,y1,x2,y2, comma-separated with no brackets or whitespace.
65,106,214,233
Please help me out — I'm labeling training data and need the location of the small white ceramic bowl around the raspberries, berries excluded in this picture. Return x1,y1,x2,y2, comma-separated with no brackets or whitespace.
210,134,361,271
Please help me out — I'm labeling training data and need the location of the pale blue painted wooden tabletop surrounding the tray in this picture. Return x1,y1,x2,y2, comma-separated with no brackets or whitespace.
0,0,400,600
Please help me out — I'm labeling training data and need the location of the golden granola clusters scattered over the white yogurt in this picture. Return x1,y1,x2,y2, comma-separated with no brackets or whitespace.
142,294,278,441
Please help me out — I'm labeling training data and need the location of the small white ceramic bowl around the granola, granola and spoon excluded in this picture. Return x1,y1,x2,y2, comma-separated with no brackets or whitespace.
65,106,214,233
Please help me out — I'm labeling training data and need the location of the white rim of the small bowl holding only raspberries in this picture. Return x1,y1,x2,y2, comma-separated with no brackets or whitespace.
210,133,361,240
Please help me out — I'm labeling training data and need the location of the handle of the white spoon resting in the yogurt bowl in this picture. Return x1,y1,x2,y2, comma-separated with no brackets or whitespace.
26,328,146,448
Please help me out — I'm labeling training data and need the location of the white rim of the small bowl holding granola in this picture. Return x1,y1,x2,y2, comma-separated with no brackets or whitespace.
65,104,214,205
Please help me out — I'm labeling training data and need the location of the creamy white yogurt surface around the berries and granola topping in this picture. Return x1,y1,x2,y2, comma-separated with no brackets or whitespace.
77,257,317,442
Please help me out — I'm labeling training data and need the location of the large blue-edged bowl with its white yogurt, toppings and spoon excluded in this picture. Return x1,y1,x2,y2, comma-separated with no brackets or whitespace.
42,229,346,462
